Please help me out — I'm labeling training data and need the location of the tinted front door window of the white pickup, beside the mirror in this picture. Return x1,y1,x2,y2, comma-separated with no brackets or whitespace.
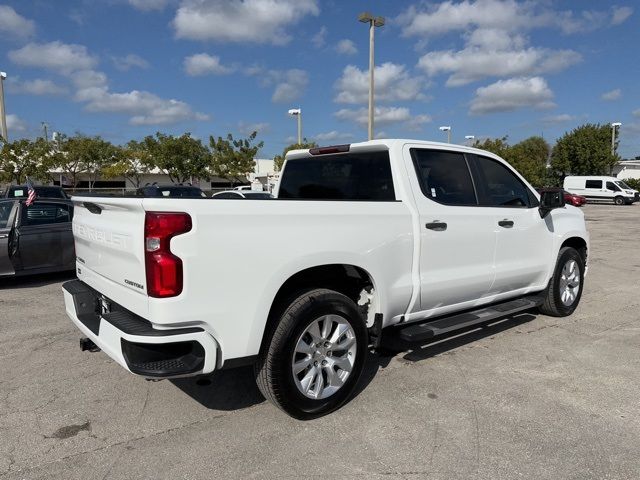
477,157,530,207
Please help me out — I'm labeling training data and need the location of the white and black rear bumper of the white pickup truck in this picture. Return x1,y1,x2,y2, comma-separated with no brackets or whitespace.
62,280,218,378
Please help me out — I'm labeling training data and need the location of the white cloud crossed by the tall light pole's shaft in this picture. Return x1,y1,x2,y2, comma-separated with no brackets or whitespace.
334,62,425,104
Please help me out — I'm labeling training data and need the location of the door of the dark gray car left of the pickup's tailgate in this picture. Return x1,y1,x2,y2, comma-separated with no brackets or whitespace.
16,201,71,270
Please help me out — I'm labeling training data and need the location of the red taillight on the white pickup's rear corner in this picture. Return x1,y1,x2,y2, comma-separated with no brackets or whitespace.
144,212,191,298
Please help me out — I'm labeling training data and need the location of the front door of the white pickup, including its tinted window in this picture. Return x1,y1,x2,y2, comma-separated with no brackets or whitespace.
473,156,553,295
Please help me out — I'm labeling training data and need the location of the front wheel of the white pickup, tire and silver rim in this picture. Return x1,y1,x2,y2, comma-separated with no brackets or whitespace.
539,247,584,317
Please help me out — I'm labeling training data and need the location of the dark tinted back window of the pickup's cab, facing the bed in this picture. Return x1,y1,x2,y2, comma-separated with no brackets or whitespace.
278,151,396,201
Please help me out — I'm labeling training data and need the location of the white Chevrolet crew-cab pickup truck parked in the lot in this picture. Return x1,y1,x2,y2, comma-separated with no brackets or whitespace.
63,140,589,419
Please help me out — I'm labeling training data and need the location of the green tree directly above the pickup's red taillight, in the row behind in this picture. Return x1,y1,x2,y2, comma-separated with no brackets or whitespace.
142,132,210,183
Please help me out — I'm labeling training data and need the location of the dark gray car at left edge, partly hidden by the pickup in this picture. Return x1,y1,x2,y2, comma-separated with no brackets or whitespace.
0,199,75,277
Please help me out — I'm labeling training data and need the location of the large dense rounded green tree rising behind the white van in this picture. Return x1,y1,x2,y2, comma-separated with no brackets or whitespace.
551,123,620,178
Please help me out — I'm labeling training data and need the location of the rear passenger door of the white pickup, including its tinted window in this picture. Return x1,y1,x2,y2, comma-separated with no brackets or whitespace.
404,145,497,311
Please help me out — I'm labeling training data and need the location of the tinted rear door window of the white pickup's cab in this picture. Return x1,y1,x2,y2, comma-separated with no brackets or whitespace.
411,148,478,206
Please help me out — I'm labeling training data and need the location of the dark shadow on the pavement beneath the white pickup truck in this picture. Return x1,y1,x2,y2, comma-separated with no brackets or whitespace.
171,313,536,411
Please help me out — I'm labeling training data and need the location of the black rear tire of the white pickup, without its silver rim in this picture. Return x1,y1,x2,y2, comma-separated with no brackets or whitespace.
254,289,368,420
